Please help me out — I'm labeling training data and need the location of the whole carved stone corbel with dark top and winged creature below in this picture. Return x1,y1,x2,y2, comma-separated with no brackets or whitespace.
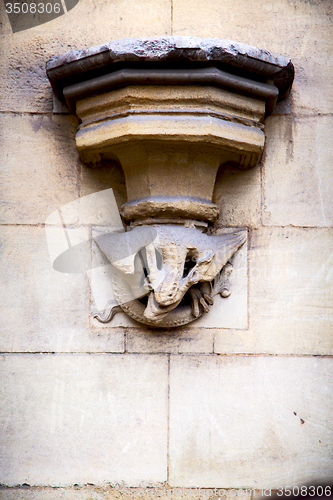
47,37,294,327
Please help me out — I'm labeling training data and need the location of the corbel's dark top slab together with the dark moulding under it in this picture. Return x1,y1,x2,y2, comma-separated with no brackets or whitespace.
46,36,294,122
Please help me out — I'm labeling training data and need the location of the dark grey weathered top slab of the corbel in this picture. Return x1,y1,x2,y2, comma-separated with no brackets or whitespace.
46,36,294,112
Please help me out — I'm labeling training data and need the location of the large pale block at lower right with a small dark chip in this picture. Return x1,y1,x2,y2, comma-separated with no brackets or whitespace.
169,356,333,488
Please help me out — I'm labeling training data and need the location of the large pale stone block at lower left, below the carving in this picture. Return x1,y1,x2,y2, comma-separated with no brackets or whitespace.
0,355,168,486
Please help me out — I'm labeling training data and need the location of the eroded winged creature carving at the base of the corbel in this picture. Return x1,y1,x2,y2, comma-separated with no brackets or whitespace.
93,224,247,327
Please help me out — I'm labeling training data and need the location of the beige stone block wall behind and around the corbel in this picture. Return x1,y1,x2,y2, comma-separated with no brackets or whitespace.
0,0,333,500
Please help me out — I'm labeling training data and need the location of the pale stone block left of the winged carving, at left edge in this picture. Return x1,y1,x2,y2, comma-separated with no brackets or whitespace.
0,226,124,352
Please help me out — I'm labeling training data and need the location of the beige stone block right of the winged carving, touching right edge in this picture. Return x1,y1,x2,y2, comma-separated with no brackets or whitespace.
215,228,333,355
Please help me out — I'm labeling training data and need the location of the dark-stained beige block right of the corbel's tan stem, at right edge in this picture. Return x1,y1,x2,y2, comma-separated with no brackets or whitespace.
263,116,333,226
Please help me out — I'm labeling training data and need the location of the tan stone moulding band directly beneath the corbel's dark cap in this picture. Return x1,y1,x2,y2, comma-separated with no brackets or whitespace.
74,86,265,122
